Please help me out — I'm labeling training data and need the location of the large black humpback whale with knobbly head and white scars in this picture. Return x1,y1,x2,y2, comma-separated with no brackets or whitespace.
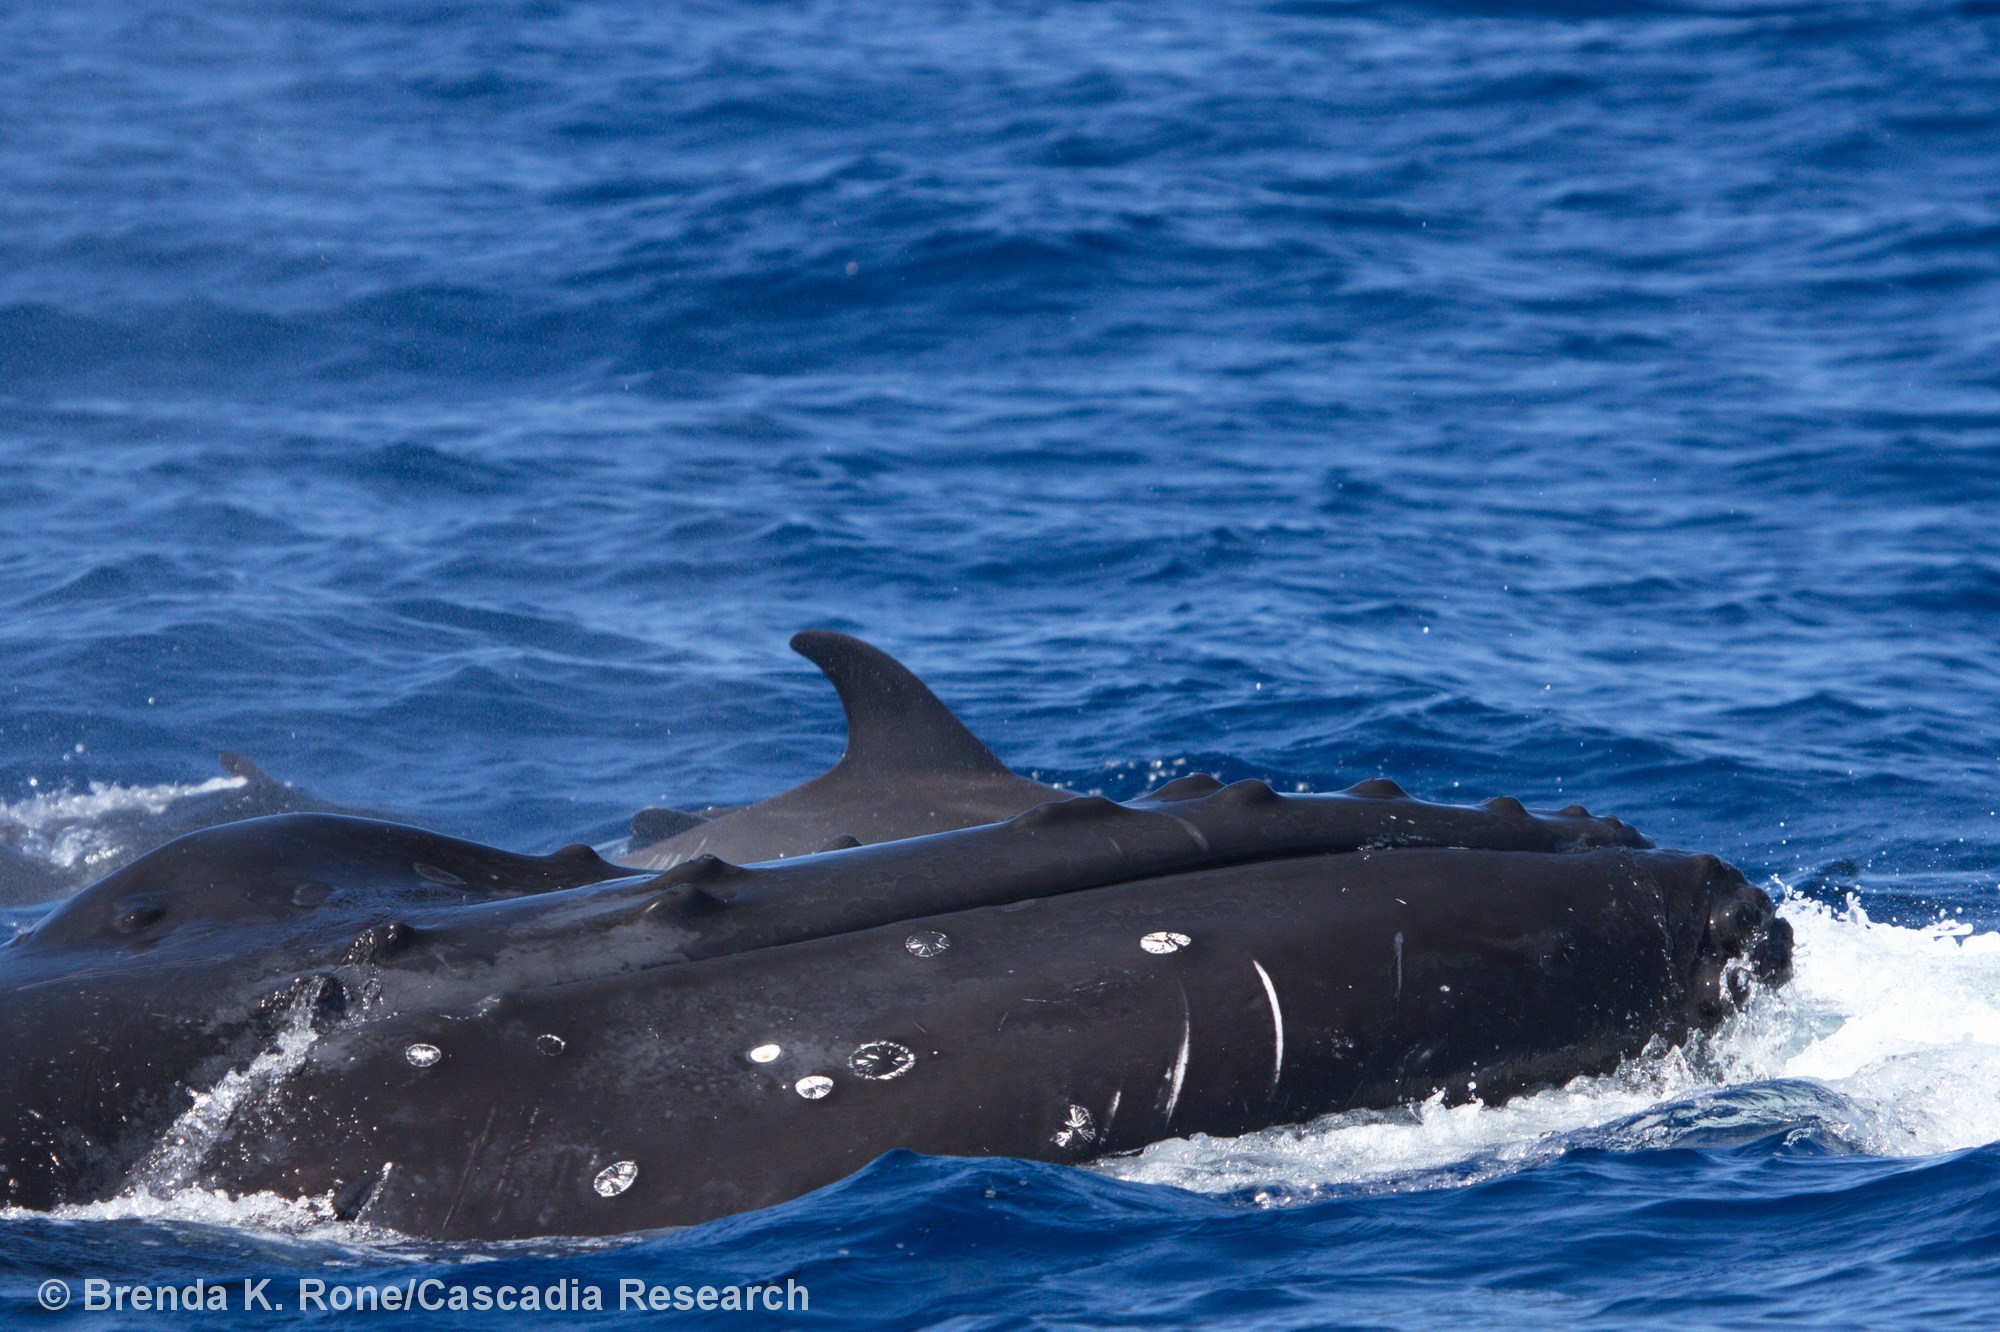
0,776,1790,1238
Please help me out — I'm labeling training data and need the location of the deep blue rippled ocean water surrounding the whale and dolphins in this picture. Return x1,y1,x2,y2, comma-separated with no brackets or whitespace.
0,0,2000,1330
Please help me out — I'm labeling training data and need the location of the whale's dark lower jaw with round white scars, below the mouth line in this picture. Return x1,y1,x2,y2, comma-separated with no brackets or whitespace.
208,850,1768,1238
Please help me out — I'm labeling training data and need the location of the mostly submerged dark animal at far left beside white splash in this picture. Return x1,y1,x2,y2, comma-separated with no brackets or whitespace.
0,752,394,906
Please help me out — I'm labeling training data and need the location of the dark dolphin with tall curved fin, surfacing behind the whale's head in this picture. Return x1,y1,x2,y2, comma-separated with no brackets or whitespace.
618,630,1070,870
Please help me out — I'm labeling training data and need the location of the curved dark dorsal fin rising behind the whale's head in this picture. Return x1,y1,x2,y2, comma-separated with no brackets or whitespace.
792,630,1012,776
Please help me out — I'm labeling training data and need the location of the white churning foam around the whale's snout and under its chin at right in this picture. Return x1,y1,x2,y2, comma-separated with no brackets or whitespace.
1096,896,2000,1202
